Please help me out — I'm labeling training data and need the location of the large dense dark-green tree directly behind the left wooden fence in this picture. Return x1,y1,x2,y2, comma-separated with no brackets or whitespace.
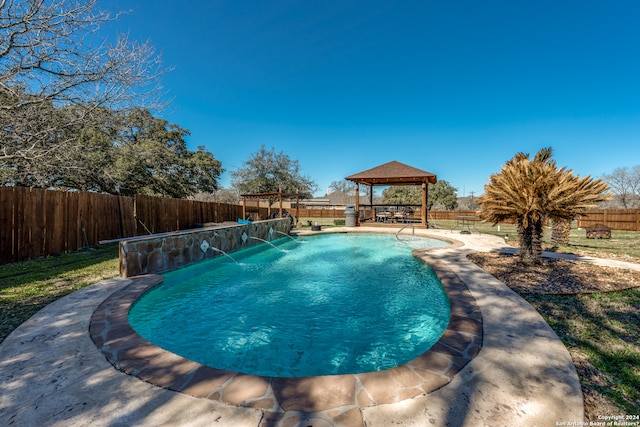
0,105,223,198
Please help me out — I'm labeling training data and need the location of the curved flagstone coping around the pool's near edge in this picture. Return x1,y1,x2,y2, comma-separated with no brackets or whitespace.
89,253,483,418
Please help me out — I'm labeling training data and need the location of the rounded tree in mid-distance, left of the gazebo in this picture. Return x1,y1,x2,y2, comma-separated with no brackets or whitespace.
231,145,317,198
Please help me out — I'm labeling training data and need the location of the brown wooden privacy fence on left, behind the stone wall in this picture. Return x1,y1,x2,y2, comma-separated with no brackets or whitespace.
0,187,250,263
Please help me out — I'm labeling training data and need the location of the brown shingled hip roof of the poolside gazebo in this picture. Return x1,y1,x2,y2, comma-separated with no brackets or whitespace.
345,160,437,185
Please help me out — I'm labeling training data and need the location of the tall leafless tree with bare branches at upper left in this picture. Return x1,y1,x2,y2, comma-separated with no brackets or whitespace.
0,0,167,185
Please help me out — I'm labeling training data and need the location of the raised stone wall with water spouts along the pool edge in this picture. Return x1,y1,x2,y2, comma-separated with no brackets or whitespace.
120,218,291,277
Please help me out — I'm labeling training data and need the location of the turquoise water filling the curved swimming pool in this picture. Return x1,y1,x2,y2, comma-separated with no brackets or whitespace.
129,233,450,377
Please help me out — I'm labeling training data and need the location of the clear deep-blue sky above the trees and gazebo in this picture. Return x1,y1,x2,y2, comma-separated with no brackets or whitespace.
102,0,640,196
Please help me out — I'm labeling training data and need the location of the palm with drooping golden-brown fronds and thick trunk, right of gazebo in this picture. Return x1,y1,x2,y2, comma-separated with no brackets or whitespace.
478,147,609,264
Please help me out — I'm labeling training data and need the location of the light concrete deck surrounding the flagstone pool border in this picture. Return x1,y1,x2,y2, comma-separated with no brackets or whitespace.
0,227,600,427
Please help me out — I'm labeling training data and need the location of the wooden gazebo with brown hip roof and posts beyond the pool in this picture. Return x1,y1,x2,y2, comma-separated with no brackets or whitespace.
345,160,437,227
